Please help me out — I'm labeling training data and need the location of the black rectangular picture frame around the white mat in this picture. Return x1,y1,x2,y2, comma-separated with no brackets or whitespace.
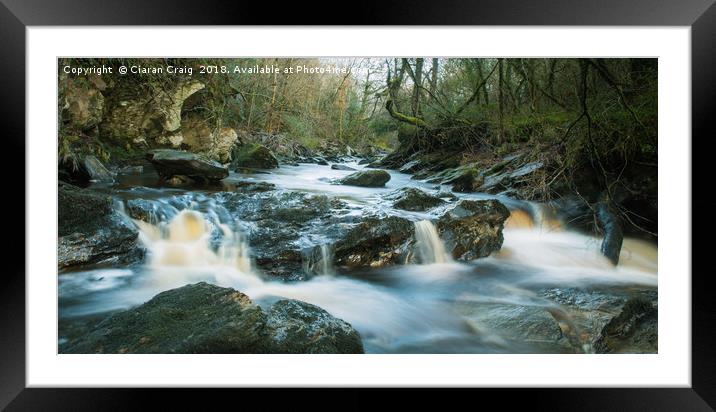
0,0,716,410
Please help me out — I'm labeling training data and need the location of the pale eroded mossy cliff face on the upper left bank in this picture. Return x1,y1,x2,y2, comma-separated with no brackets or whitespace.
58,67,237,163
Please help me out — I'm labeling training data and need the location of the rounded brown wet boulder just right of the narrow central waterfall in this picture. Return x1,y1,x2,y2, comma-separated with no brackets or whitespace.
436,199,510,260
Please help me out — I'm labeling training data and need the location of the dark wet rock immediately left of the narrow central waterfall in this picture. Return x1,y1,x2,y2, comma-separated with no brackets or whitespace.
334,216,414,268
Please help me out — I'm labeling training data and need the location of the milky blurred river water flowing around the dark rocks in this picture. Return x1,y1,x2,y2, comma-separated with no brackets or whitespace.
59,163,657,353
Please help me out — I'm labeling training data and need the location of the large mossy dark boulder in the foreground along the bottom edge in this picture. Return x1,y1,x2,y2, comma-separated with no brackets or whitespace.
63,282,363,353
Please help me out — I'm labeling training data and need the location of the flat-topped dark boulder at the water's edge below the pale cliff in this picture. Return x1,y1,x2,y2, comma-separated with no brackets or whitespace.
147,149,229,181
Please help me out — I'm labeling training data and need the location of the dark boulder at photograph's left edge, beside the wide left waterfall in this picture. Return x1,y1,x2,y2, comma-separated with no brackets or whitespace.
57,184,144,269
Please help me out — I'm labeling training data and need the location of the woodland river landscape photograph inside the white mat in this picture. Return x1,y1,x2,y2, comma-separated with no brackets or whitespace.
56,56,658,354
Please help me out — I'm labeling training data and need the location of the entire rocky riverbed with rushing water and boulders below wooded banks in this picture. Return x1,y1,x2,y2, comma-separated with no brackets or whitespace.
58,153,657,353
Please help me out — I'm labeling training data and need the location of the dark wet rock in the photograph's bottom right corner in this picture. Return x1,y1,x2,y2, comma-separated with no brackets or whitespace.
594,296,658,353
